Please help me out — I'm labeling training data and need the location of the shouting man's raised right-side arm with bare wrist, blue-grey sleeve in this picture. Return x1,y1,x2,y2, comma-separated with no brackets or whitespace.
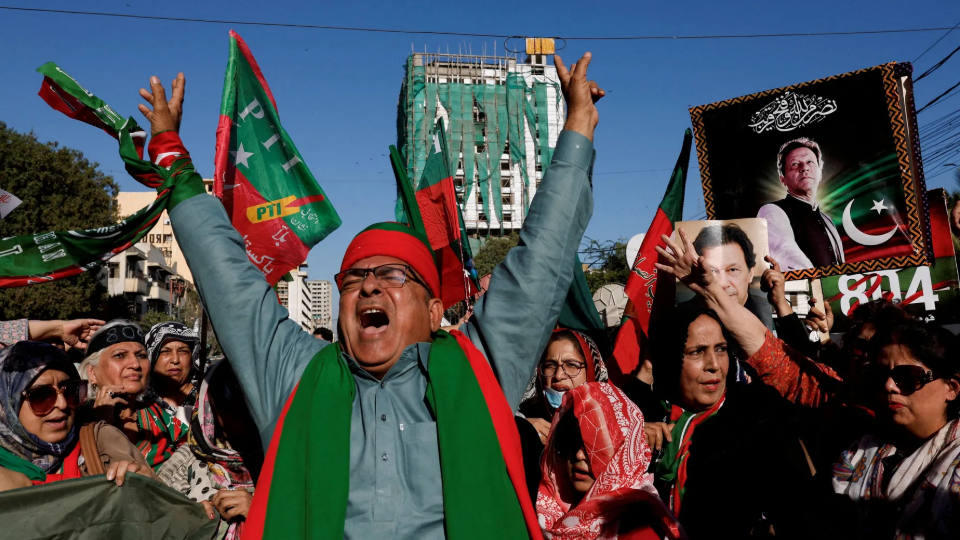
463,53,604,409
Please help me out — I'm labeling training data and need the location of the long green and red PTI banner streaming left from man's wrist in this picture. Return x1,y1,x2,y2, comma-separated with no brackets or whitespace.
0,62,171,287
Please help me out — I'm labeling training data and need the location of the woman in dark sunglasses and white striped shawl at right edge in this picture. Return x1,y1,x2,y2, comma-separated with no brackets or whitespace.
833,321,960,539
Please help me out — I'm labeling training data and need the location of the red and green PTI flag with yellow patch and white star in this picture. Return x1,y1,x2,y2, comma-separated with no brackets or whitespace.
213,30,340,285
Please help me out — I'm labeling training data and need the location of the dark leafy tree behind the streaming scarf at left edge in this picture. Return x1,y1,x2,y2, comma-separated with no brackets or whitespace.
0,122,119,319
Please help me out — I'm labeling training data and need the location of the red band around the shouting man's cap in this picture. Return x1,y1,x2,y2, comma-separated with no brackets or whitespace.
340,223,440,297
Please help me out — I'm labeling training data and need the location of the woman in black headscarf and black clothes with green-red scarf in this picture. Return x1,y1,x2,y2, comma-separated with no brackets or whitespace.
648,304,817,540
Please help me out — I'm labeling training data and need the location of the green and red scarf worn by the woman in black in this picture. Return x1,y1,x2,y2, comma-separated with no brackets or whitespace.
656,392,727,517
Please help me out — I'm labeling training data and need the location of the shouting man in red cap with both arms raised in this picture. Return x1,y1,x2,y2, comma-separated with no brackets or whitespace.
141,53,604,540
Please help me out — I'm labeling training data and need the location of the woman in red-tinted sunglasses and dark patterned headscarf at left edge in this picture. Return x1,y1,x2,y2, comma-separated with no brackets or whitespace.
0,341,155,491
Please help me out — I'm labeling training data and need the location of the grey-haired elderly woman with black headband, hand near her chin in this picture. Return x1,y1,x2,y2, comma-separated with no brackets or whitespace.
80,319,187,470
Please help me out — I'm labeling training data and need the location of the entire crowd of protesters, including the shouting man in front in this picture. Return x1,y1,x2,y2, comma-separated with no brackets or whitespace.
0,53,960,540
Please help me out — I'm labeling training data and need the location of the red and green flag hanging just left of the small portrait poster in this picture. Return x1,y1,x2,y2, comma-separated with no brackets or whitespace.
613,129,693,375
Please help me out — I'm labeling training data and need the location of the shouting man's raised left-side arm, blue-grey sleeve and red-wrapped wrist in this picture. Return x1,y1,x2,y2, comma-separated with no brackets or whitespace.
140,74,324,448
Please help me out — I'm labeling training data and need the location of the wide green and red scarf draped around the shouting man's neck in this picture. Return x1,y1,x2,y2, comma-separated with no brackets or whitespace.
244,331,541,540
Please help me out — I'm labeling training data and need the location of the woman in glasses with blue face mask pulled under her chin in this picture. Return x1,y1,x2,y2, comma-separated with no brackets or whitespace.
520,328,608,443
